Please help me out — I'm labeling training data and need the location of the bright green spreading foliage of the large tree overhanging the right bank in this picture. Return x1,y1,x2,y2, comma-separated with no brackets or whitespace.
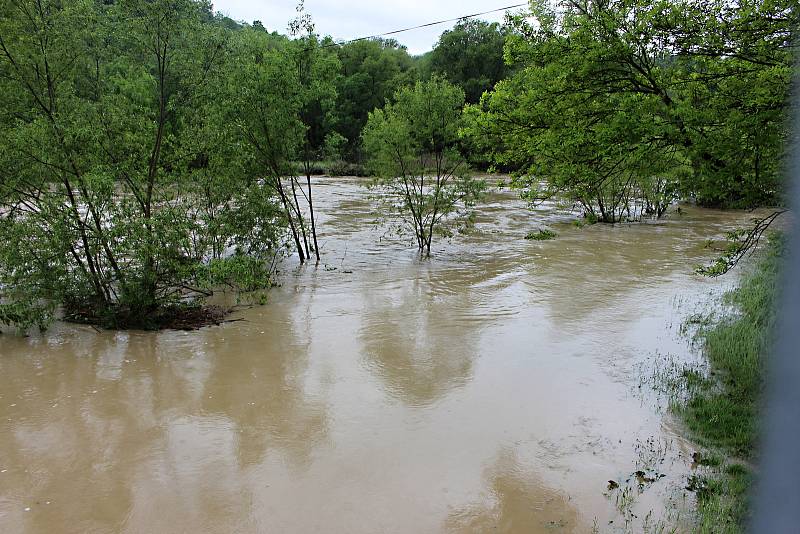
467,0,796,222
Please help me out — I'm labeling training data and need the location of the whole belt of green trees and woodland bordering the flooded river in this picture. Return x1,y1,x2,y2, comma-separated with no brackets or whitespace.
0,0,798,329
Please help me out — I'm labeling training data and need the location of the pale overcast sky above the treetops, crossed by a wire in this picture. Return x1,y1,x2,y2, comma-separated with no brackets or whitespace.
209,0,524,54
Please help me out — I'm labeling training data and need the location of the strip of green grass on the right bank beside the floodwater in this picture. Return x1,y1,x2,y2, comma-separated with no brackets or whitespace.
676,237,782,534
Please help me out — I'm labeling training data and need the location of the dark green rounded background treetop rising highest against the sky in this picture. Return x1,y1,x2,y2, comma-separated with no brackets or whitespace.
428,19,508,104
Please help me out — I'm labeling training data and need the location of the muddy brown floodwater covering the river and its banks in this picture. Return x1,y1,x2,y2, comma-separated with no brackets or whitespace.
0,178,750,533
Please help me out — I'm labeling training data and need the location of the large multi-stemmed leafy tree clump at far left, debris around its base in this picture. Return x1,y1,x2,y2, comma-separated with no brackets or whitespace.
0,0,286,327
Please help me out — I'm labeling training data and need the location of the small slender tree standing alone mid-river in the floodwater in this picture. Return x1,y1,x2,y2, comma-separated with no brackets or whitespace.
363,77,485,256
